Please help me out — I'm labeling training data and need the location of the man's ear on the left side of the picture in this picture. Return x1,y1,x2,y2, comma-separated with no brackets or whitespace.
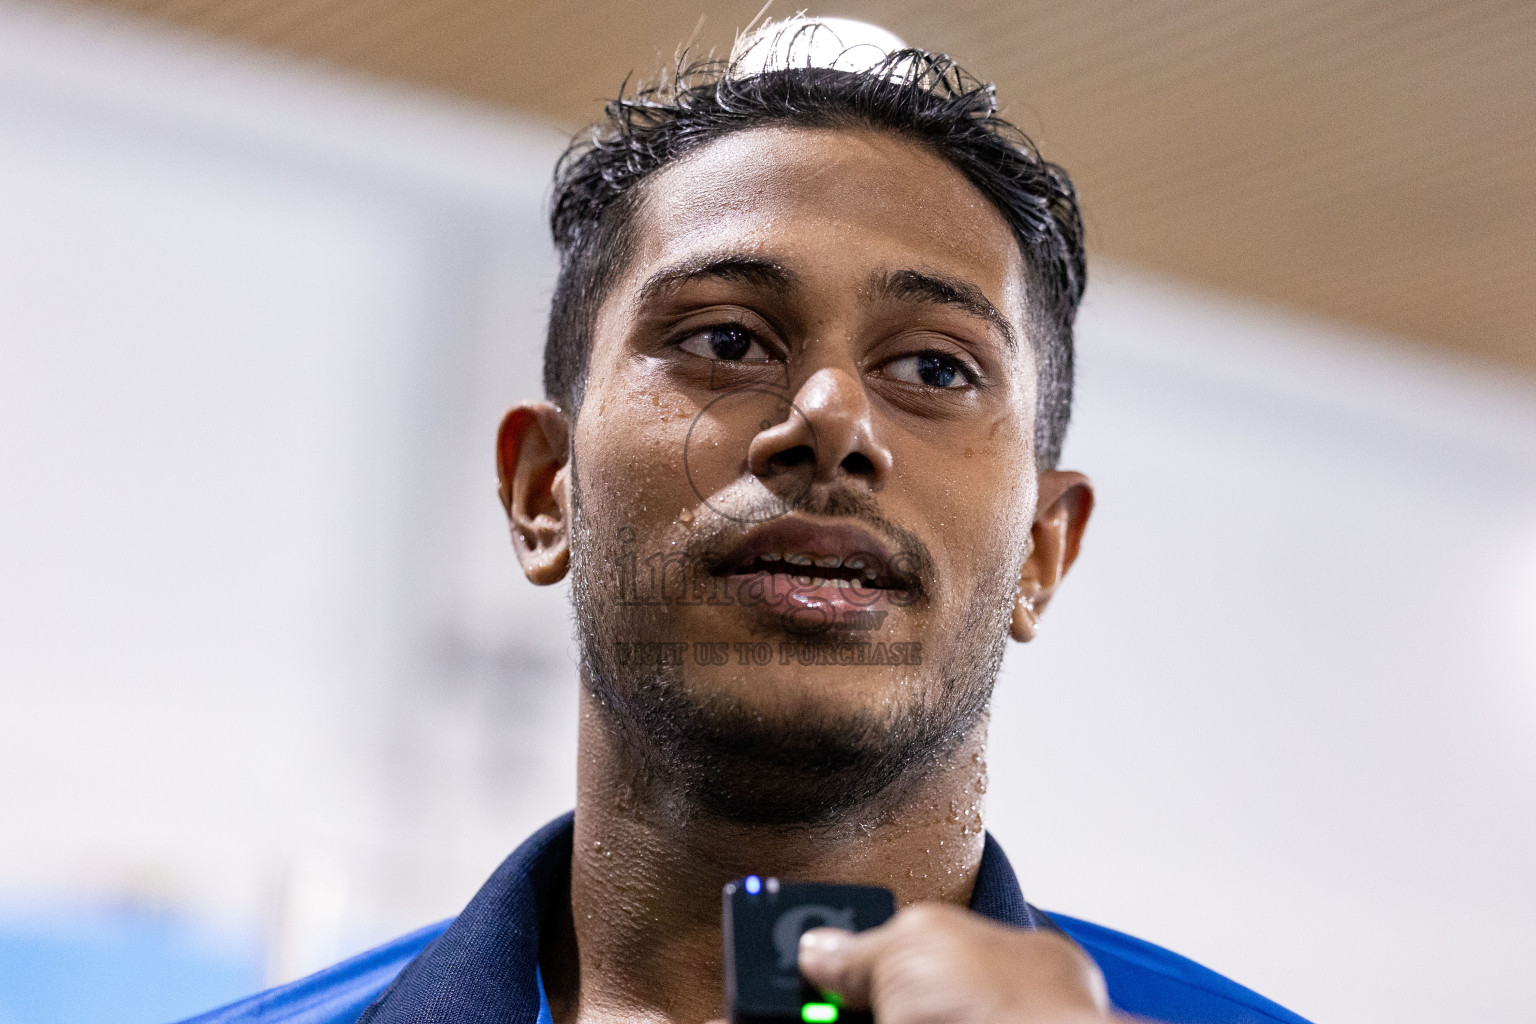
496,402,571,586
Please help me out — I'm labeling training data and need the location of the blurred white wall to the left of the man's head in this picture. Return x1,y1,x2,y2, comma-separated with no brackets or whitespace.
0,6,571,973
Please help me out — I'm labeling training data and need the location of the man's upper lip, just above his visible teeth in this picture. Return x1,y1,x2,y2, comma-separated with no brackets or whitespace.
716,516,905,590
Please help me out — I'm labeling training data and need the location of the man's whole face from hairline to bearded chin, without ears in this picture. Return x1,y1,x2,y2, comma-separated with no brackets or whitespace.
571,129,1035,818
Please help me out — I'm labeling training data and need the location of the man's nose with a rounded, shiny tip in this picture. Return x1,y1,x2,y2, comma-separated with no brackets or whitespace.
746,367,892,491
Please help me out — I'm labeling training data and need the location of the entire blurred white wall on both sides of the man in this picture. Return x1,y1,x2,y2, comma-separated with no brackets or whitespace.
0,3,1536,1022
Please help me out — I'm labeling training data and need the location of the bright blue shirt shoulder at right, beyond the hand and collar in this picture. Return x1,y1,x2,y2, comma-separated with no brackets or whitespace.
1049,913,1307,1024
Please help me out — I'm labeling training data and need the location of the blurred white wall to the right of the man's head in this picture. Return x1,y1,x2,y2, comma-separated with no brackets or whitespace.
992,267,1536,1021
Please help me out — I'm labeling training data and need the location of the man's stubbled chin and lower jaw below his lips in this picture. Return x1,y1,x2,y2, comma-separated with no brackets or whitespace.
584,649,988,827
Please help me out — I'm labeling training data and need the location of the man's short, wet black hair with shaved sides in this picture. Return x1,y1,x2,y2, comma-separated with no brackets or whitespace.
544,49,1087,468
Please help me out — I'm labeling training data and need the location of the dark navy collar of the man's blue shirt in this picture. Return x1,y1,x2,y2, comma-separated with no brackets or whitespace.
358,812,1057,1024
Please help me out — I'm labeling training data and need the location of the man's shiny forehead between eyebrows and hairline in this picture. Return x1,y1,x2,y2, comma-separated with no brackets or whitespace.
630,127,1028,323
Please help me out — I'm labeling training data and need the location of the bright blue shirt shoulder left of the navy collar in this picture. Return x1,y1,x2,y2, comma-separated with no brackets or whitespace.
183,921,449,1024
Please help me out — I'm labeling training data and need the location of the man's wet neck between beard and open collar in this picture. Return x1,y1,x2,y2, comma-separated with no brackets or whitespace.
541,688,986,1024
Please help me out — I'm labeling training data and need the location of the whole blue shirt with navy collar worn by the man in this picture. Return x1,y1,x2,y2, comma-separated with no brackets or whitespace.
186,814,1307,1024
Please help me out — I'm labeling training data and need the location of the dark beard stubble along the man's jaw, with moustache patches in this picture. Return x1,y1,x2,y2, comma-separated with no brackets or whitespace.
571,473,1018,829
